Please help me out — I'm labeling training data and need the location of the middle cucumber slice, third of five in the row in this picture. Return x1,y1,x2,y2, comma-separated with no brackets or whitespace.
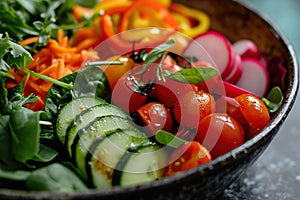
71,115,132,179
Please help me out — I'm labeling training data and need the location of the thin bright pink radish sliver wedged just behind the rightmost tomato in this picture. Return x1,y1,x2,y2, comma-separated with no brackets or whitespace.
213,81,253,98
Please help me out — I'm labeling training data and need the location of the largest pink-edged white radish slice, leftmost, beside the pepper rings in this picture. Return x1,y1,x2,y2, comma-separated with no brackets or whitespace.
183,31,233,77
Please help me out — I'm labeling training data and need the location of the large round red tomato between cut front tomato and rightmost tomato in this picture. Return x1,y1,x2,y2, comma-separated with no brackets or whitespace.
196,113,244,158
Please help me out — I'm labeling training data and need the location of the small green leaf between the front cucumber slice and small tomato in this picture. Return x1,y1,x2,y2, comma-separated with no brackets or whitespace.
155,130,187,148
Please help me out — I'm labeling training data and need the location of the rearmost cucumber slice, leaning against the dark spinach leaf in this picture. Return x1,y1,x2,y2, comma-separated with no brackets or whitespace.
56,97,106,143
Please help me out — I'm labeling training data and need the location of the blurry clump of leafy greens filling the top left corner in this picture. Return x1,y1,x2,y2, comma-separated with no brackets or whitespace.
0,0,75,46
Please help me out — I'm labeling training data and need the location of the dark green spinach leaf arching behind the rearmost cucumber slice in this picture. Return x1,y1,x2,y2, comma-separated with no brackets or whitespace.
45,67,110,119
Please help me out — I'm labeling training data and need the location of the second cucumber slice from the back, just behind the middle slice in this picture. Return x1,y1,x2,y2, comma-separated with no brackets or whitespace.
65,104,128,157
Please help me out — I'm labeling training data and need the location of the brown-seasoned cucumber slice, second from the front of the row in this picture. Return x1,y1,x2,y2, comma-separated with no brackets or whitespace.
85,129,149,189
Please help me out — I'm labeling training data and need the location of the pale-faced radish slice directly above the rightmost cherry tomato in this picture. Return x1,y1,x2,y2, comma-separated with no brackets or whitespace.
236,58,270,97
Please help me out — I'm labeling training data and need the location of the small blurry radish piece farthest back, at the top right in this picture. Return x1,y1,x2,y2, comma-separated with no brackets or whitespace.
232,39,261,59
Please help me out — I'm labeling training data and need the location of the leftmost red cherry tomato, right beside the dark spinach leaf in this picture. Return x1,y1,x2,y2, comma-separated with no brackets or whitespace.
111,74,147,113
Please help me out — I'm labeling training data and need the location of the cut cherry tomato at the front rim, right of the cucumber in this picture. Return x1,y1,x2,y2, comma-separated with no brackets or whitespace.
165,141,211,176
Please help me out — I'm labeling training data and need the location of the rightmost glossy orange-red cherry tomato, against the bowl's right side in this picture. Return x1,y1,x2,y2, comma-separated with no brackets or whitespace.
235,94,270,138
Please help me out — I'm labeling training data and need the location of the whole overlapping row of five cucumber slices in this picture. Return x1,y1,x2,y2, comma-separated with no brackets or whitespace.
56,97,166,189
